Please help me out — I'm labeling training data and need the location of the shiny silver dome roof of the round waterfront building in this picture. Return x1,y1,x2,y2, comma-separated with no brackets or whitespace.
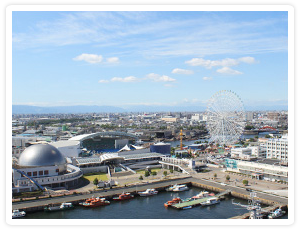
19,144,66,166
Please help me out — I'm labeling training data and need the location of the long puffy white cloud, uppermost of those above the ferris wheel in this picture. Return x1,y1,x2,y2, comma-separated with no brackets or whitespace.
185,57,255,69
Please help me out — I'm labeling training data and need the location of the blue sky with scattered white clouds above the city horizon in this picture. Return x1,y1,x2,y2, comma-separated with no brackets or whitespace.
12,11,288,108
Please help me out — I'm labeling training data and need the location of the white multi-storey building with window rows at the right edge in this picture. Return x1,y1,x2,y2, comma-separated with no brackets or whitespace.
267,136,288,162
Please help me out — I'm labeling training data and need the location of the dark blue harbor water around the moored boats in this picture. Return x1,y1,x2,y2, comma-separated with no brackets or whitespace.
18,187,286,219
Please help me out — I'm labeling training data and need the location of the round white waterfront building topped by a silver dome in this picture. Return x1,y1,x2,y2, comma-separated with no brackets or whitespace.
13,144,82,193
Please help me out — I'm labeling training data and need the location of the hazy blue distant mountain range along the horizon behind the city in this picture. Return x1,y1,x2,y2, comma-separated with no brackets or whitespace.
12,105,288,114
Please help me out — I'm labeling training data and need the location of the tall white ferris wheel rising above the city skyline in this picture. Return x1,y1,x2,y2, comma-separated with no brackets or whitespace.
205,90,245,145
